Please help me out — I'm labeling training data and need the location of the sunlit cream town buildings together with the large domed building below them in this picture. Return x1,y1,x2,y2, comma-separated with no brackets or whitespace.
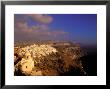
15,44,57,75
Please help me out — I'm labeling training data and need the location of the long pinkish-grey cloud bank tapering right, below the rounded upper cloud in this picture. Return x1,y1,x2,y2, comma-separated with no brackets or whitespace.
15,22,67,36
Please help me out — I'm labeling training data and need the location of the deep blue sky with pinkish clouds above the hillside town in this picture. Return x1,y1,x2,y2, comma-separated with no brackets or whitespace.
14,14,97,45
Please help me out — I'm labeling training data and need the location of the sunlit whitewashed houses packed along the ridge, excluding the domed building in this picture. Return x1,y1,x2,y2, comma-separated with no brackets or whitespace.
18,44,57,58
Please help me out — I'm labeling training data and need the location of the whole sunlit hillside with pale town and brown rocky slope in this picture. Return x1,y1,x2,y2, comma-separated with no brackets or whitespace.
14,43,86,76
